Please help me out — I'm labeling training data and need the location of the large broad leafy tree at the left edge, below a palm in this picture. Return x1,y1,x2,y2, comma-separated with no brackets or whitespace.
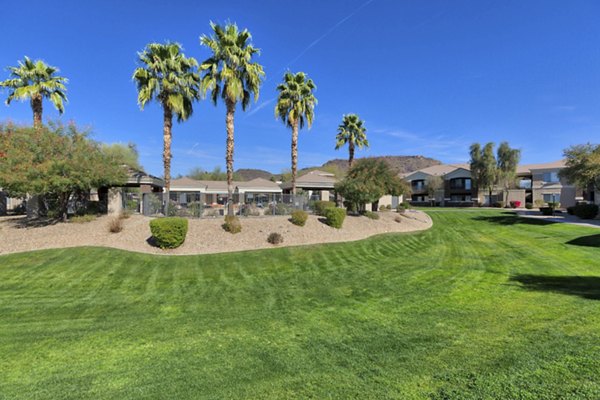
0,124,127,220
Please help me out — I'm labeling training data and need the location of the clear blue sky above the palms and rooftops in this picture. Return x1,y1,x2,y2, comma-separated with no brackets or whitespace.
0,0,600,174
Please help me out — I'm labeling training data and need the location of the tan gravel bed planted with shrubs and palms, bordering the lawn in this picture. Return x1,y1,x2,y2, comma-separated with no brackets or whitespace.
0,210,432,255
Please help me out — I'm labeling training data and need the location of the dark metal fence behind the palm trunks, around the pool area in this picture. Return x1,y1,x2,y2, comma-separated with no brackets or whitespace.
137,192,315,218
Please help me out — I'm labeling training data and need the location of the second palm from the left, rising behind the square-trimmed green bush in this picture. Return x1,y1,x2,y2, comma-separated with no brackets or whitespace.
133,42,200,214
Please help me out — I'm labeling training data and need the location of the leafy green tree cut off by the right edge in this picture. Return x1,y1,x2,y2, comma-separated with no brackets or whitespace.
559,143,600,190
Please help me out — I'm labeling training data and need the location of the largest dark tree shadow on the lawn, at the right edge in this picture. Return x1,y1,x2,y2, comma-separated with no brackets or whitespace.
510,274,600,300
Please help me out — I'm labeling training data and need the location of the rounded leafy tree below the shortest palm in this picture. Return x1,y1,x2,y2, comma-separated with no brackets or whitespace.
335,158,408,211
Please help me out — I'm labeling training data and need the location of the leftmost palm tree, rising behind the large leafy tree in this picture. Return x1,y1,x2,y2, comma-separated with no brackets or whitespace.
0,56,68,126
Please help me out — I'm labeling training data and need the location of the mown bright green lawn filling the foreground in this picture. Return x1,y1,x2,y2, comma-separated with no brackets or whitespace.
0,210,600,399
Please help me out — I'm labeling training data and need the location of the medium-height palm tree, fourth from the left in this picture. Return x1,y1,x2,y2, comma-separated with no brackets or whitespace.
275,72,317,195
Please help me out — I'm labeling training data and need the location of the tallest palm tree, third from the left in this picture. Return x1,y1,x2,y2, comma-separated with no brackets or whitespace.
200,22,265,215
